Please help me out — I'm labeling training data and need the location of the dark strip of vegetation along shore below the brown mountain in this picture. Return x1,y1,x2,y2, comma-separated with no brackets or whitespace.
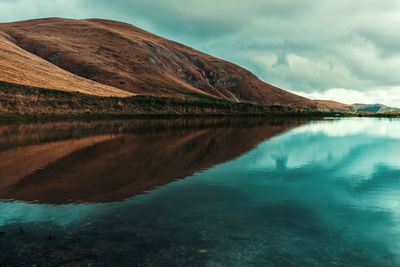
0,82,340,120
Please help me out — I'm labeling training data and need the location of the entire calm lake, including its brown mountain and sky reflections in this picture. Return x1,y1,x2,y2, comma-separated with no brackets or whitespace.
0,118,400,267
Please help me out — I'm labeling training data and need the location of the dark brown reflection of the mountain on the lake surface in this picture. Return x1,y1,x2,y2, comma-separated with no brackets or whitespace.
0,119,304,204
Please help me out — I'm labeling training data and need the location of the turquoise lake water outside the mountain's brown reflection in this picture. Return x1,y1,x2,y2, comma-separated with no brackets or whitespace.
0,119,400,267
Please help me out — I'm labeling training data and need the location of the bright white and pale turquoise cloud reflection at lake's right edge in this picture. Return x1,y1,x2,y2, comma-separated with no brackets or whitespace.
249,119,400,179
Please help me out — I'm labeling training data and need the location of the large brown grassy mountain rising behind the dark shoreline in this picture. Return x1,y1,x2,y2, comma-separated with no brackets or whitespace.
0,18,316,107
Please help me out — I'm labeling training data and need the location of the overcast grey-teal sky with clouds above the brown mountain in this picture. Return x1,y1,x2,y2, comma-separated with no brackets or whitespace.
0,0,400,107
